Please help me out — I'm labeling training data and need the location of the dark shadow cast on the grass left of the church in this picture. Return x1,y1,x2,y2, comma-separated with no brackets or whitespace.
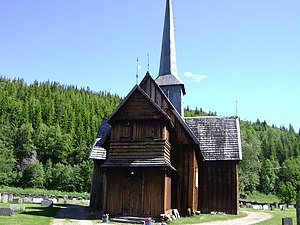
20,204,96,220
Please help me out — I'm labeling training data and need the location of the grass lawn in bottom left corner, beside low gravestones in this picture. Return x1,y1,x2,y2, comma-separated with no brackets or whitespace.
0,203,60,225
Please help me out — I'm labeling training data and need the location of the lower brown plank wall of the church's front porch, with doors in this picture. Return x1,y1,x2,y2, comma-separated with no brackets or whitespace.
106,168,171,216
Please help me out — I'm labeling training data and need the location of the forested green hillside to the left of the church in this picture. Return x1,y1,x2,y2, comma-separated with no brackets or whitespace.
0,78,121,192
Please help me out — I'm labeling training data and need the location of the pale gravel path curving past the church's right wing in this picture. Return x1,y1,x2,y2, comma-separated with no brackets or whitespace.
199,211,272,225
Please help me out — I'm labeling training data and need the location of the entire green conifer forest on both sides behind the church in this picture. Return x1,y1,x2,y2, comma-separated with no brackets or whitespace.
0,77,300,202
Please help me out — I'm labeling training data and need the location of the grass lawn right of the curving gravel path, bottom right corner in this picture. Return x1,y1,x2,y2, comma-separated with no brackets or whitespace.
243,209,297,225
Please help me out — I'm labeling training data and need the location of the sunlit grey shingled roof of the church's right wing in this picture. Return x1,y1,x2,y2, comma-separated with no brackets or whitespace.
184,116,242,161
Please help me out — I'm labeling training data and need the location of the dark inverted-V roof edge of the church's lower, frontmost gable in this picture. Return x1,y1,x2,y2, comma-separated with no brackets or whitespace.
107,85,174,127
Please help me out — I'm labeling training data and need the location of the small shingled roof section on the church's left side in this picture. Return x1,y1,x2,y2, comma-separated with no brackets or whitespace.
89,118,110,160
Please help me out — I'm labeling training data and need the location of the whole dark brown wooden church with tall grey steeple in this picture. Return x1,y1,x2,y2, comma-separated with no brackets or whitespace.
90,0,242,216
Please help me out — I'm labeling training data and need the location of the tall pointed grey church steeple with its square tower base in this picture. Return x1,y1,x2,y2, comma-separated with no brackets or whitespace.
155,0,185,116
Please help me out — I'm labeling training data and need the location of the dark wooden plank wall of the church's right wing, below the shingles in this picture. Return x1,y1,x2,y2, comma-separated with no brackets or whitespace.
198,161,239,214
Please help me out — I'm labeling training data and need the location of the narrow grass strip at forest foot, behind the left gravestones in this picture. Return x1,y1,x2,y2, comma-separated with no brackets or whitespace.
0,186,90,198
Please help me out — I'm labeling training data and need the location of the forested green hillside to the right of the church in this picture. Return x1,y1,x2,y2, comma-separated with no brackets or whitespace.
239,120,300,202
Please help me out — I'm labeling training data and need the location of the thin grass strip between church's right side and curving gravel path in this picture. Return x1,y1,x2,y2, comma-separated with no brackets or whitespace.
168,213,246,225
